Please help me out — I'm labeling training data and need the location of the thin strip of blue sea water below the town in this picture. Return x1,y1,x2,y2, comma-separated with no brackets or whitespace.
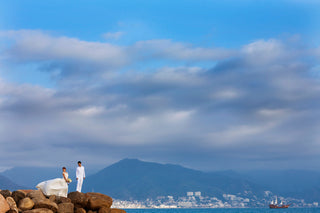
126,208,320,213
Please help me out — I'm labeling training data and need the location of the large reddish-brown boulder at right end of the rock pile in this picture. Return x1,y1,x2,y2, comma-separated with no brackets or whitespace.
86,192,112,210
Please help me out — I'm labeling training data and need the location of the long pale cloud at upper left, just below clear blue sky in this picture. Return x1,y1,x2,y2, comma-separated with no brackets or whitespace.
2,30,128,66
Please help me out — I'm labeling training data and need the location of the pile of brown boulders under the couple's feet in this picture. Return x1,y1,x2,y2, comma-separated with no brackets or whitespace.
0,190,126,213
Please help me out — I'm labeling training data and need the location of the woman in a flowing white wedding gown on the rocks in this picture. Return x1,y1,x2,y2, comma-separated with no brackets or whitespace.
36,167,70,197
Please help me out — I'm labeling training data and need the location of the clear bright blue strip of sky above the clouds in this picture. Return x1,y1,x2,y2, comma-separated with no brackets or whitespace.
2,0,319,47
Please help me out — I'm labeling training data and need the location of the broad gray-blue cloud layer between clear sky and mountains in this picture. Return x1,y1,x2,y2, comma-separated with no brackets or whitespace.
0,31,320,169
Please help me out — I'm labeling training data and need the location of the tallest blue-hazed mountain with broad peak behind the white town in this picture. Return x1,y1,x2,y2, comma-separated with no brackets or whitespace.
84,159,263,200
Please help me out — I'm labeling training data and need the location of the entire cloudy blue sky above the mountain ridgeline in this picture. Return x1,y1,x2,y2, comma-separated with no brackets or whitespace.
0,0,320,170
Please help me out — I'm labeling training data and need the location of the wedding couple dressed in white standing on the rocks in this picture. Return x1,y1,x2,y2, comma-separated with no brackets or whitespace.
36,161,86,197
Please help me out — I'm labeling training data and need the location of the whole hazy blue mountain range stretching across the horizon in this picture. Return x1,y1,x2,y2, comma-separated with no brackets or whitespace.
0,159,320,202
